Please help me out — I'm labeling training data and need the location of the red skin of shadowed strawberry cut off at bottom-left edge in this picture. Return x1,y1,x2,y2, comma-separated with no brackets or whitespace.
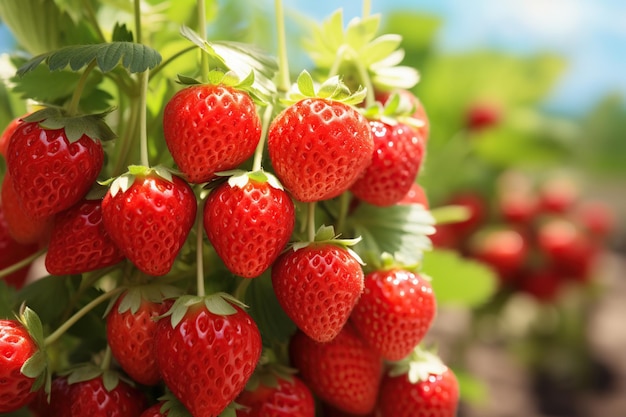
70,376,147,417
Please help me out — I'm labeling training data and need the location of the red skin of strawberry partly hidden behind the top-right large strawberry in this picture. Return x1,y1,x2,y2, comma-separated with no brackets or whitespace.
350,120,425,207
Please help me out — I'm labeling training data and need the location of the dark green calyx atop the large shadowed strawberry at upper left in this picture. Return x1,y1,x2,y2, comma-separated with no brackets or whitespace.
24,107,117,143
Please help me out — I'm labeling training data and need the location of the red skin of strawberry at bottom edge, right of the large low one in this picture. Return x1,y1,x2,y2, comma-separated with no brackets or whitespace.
235,376,315,417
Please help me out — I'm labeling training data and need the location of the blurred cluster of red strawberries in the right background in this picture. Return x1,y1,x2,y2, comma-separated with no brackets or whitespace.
432,171,614,303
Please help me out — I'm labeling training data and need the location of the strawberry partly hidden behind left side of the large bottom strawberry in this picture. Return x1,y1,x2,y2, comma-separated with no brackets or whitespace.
106,285,170,385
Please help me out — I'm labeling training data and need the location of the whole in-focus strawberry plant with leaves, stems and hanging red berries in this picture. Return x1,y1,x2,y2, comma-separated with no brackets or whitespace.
0,0,502,417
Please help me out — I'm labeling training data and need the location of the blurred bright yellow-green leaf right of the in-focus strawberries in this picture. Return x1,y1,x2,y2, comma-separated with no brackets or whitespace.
422,250,498,308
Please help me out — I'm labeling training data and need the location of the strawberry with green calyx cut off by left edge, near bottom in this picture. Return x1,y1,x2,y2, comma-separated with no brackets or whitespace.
0,309,46,414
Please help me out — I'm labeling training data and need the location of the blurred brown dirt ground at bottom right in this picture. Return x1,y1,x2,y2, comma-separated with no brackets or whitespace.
432,253,626,417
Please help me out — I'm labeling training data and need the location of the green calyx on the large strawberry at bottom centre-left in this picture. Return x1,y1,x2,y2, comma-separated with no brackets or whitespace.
159,292,248,328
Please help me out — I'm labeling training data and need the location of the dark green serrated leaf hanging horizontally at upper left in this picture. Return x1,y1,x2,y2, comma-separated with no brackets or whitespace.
17,41,162,76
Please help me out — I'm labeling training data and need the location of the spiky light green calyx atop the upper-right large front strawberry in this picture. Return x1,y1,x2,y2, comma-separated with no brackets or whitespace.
281,70,367,105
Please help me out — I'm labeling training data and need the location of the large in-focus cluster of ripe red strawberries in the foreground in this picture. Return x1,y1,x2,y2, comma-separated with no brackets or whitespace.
0,5,459,417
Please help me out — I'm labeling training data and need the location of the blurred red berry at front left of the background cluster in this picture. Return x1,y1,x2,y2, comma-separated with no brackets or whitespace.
469,228,529,283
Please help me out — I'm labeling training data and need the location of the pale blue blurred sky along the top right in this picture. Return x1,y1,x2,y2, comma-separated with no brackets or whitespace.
0,0,626,112
